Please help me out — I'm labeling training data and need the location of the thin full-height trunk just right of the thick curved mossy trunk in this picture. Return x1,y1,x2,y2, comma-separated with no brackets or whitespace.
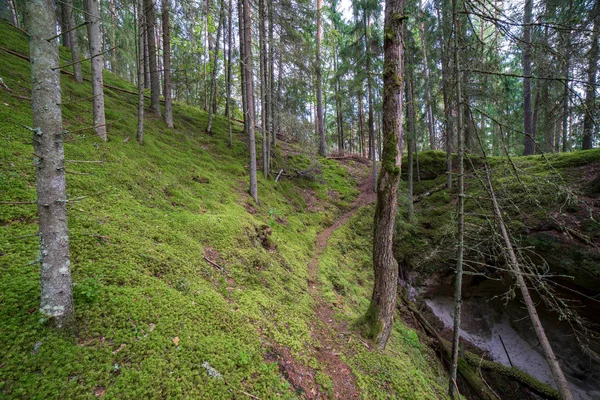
449,0,465,398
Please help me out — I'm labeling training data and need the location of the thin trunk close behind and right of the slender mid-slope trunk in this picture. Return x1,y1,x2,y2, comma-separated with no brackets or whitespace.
258,0,271,178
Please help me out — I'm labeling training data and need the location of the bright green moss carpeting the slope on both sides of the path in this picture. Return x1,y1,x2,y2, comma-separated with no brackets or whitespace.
0,23,444,399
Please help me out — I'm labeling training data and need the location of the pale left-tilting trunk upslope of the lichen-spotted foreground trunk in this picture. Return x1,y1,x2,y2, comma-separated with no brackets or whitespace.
83,0,108,141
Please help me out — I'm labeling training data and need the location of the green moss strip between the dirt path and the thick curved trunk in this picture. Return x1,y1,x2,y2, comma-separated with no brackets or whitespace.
319,207,447,399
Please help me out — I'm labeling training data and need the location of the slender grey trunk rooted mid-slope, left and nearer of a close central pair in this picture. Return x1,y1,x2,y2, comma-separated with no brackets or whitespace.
243,0,258,203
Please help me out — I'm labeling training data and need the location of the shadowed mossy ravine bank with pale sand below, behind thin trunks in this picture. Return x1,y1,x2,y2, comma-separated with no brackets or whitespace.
396,150,600,399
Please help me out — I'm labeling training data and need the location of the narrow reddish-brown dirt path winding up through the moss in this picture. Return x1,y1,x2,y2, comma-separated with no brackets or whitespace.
276,172,376,399
